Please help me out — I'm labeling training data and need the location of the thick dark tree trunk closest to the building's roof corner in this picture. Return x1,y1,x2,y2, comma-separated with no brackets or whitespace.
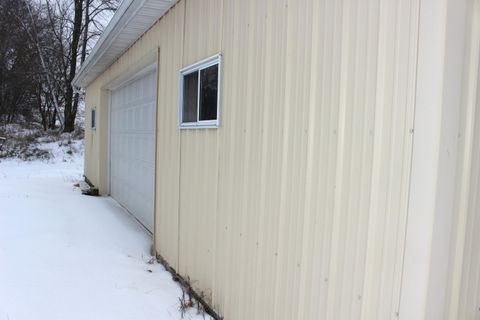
63,0,83,132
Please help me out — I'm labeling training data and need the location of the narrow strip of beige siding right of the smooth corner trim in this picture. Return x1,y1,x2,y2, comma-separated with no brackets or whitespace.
447,0,480,320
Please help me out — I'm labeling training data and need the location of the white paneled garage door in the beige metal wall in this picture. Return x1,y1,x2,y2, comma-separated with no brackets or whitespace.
110,71,156,231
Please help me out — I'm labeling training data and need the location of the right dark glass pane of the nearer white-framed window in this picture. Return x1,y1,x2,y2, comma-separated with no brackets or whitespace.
200,64,218,120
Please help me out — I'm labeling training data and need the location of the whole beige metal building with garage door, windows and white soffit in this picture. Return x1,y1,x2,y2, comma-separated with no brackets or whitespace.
75,0,480,320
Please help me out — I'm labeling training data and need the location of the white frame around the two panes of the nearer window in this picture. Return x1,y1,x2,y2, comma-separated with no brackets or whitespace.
178,53,222,129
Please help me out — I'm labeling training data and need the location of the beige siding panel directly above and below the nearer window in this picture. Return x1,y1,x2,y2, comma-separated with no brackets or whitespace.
176,0,222,296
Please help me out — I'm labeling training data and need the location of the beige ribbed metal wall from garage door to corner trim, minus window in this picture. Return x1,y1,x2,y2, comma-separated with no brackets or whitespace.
87,0,419,320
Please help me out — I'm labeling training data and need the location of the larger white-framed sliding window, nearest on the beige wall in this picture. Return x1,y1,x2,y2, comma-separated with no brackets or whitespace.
178,54,222,129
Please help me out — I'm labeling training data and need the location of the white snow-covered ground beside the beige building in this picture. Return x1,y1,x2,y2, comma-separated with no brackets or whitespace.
0,141,209,320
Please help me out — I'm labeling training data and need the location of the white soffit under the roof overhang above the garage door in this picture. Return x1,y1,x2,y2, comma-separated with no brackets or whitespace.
73,0,177,88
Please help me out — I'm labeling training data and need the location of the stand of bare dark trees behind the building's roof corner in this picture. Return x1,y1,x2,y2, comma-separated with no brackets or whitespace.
0,0,120,132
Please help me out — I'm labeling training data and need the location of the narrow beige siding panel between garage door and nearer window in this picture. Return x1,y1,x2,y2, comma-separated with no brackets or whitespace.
153,1,184,270
